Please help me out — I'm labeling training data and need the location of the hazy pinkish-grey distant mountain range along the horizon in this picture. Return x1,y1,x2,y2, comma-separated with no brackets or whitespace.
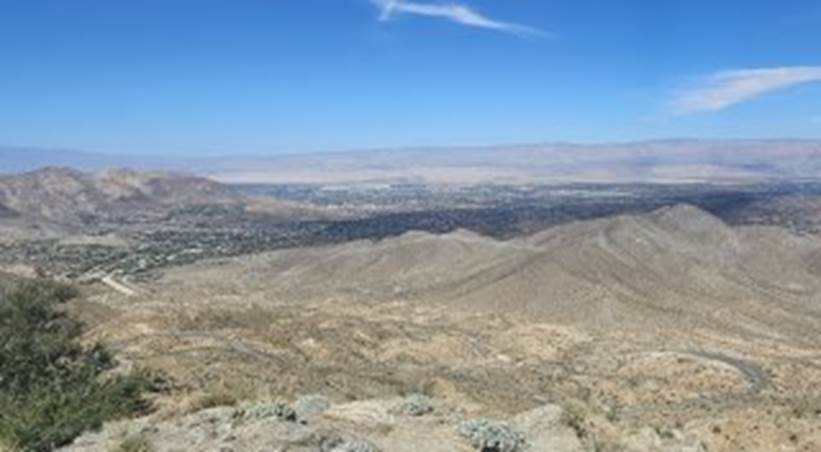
0,140,821,184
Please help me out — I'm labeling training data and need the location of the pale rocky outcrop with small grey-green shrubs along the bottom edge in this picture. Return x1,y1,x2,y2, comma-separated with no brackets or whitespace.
63,398,586,452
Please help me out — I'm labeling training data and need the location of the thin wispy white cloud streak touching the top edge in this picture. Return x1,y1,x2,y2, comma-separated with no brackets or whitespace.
371,0,544,35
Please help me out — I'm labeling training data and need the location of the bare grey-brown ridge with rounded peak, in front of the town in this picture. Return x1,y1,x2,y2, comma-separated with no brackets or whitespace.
152,206,821,340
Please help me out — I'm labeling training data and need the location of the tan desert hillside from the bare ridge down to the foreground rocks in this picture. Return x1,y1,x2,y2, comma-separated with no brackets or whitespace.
62,206,821,452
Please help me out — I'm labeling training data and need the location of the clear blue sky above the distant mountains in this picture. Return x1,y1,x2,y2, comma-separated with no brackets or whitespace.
0,0,821,154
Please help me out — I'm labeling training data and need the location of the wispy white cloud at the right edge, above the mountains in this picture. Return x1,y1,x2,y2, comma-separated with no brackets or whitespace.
675,66,821,113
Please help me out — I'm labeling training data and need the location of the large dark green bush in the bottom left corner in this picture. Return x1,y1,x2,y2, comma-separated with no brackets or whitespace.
0,280,149,452
